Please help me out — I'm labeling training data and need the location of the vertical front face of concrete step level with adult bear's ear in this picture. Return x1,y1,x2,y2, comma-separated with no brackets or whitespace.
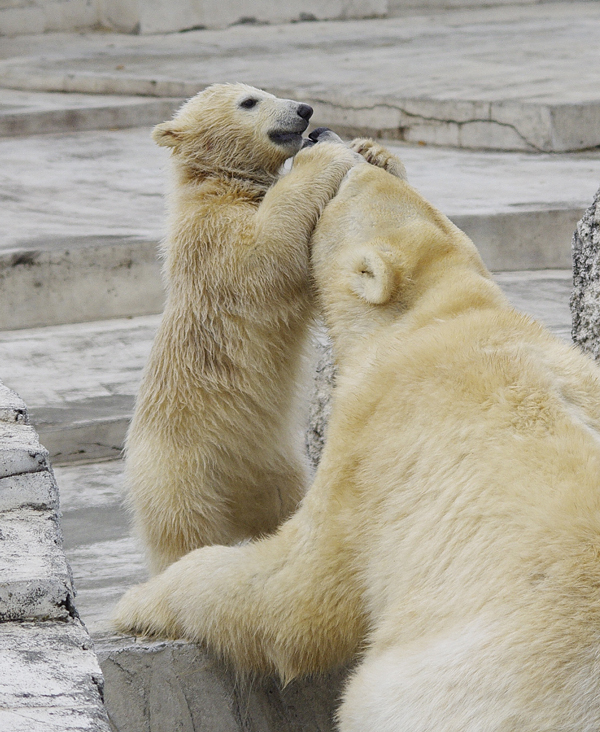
0,207,583,332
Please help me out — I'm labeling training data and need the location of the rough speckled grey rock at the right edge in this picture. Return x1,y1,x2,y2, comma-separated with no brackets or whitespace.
571,189,600,360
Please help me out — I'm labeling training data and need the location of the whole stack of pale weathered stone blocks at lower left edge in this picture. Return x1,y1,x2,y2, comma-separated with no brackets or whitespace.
0,384,110,732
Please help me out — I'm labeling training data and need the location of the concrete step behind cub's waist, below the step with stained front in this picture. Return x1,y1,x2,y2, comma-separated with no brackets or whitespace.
0,270,571,463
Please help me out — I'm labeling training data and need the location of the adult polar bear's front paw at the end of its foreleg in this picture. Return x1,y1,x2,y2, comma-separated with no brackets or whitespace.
112,575,183,638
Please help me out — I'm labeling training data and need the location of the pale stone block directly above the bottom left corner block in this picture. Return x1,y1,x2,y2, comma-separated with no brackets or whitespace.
0,508,75,622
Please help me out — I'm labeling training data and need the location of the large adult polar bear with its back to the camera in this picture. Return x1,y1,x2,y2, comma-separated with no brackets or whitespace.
116,134,600,732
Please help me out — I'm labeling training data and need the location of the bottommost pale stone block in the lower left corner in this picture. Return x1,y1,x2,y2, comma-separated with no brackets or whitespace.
0,622,110,732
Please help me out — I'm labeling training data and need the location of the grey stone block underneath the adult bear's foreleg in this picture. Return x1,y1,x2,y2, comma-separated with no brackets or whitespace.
96,637,347,732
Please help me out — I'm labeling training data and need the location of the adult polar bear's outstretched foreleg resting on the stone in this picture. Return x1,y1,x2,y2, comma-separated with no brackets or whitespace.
114,500,366,681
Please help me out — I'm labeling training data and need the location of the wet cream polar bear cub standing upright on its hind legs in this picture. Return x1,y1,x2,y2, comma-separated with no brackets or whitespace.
126,84,356,571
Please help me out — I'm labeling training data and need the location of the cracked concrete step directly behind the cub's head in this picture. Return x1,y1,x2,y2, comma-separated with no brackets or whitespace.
0,2,600,152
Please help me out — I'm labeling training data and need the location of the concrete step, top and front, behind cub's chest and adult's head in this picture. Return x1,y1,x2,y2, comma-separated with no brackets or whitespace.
0,127,600,330
